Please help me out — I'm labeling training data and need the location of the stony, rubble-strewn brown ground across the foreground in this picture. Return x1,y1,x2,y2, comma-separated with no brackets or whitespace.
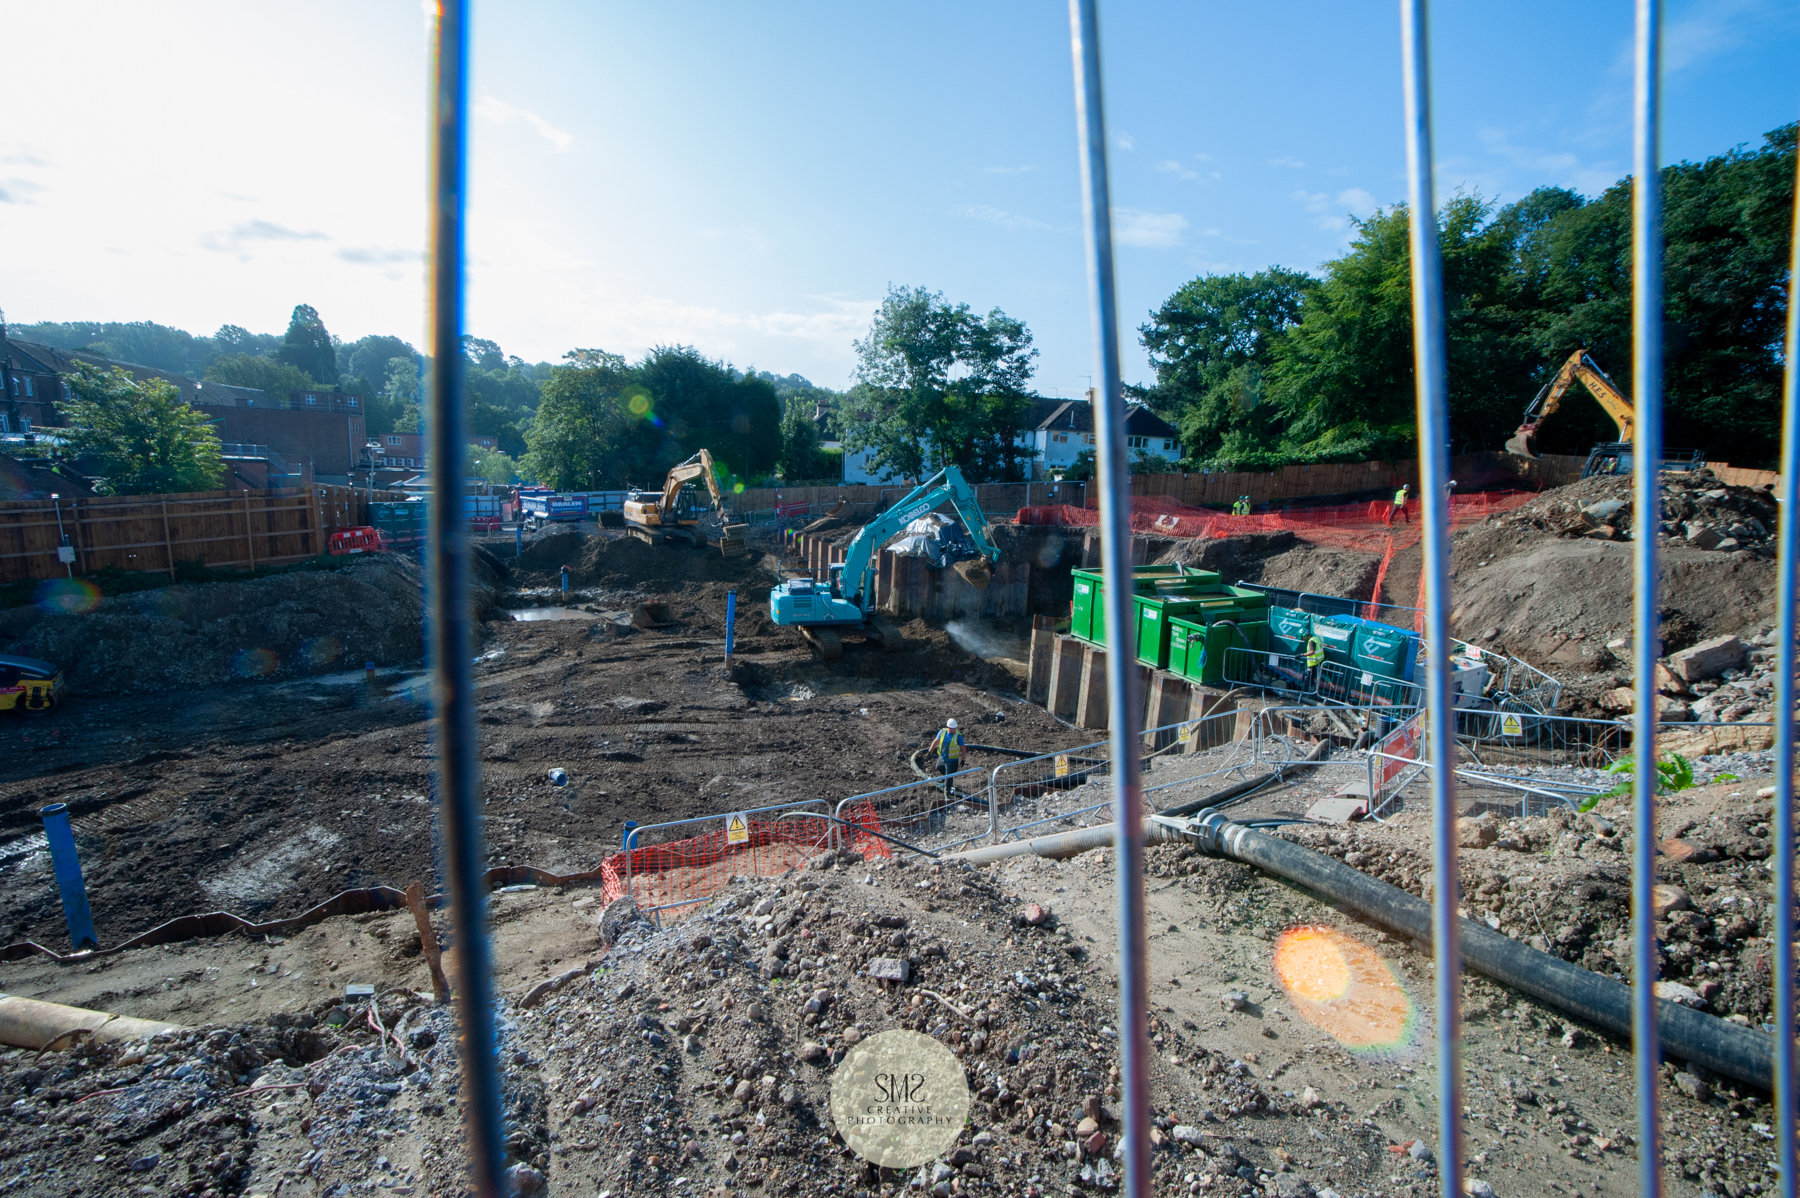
0,779,1773,1198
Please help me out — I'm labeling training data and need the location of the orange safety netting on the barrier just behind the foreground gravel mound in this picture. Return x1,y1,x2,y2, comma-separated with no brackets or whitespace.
599,804,893,910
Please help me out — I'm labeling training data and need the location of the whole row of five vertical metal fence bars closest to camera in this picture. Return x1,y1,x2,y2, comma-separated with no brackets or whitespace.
408,0,1800,1198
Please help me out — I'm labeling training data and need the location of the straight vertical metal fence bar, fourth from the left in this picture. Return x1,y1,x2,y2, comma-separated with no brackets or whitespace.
1631,0,1663,1198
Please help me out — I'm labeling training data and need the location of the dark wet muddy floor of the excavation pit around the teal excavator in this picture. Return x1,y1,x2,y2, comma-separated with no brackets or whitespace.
0,536,1084,950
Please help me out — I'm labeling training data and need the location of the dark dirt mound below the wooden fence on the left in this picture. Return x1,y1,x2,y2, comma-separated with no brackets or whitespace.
7,554,430,694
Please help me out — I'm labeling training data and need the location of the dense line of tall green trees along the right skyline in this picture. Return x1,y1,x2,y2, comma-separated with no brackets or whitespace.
1138,124,1796,469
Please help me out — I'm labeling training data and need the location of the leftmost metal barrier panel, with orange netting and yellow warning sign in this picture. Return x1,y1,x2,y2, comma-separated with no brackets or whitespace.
603,799,835,923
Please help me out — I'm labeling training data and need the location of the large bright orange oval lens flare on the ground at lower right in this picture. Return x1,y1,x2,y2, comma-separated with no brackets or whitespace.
1274,926,1418,1052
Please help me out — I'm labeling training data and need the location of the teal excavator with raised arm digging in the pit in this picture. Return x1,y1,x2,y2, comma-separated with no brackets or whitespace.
769,466,1001,662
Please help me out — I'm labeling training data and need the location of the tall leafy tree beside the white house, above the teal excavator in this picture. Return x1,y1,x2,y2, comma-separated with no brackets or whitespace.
841,288,1037,482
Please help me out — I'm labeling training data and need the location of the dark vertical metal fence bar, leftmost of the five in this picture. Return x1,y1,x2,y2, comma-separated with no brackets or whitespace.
428,0,506,1198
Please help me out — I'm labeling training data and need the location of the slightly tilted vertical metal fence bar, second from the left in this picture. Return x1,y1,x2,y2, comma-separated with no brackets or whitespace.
1069,0,1150,1198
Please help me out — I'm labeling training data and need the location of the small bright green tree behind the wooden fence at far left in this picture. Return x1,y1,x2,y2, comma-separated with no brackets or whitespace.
58,362,225,495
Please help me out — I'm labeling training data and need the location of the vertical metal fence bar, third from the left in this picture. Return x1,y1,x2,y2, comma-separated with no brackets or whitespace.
1400,0,1463,1198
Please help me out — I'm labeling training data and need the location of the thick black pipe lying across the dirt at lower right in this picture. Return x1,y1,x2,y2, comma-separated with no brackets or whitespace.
1195,815,1775,1090
